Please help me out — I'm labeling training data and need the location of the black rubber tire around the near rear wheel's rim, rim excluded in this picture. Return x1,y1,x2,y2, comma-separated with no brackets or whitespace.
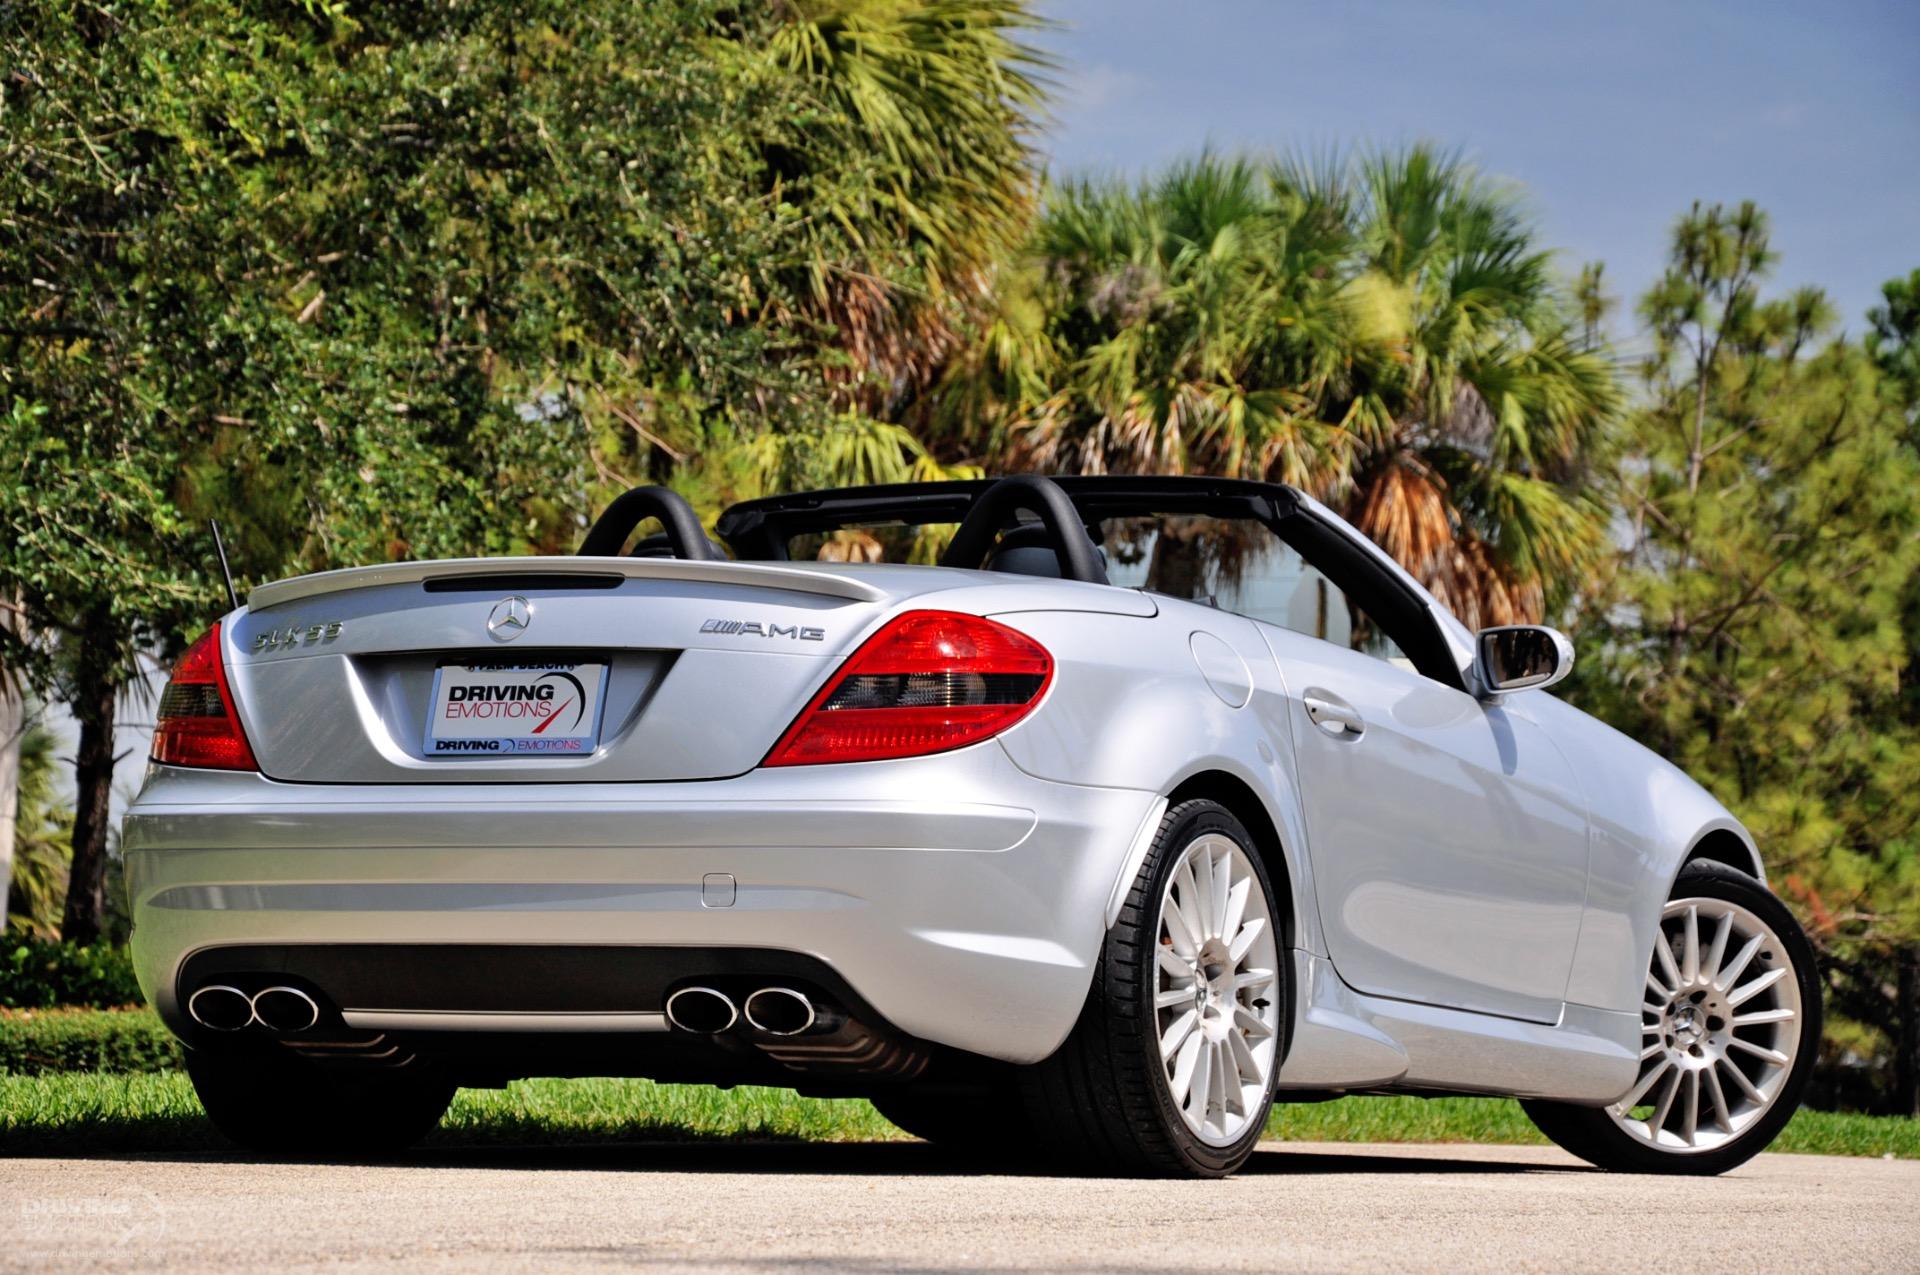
1020,801,1290,1177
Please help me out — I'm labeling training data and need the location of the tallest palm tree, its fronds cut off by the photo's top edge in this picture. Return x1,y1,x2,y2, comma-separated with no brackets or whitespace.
591,0,1050,513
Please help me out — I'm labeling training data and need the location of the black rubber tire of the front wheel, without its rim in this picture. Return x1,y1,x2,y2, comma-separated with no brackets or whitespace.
1521,860,1820,1175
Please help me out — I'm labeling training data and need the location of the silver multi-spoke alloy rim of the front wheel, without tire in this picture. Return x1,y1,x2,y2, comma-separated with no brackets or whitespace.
1607,899,1801,1152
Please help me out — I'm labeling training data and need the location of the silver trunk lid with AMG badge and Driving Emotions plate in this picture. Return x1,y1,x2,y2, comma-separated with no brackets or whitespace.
223,557,893,783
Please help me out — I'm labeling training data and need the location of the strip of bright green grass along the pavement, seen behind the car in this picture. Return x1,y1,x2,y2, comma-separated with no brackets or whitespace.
0,1071,1920,1160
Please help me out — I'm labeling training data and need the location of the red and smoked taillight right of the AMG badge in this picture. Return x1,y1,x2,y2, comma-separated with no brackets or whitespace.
762,611,1054,766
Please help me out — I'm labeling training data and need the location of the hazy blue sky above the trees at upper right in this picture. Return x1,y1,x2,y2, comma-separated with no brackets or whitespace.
1043,0,1920,332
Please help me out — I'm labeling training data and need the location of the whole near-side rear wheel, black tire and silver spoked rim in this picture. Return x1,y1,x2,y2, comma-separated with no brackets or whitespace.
1021,801,1284,1177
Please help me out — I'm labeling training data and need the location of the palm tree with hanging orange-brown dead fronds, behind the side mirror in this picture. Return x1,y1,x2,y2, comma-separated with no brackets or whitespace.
1344,146,1620,626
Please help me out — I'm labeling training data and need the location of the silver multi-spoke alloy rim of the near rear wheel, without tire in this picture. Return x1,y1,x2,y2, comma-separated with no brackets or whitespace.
1154,833,1281,1146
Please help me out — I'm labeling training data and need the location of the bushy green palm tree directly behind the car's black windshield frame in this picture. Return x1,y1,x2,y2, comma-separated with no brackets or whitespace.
995,157,1363,488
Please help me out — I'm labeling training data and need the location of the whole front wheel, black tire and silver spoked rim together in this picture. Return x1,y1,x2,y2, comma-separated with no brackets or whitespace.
1523,862,1820,1173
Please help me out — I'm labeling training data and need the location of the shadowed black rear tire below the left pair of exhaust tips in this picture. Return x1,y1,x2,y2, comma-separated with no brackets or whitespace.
186,1045,453,1158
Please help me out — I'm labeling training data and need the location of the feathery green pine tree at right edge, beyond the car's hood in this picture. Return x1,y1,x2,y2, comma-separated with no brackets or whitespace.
1576,204,1920,1110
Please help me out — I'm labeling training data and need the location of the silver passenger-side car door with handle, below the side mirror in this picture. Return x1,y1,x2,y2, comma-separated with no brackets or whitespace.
1261,602,1588,1022
